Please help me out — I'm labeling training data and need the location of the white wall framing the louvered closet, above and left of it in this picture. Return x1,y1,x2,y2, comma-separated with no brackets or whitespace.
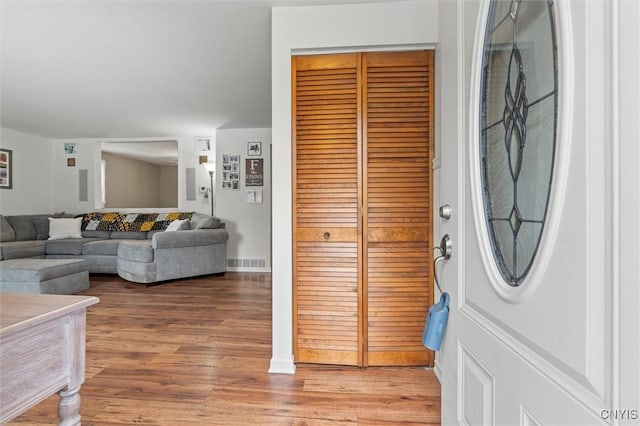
269,0,438,373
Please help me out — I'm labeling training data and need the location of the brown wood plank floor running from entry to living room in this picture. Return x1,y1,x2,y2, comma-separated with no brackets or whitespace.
10,273,440,426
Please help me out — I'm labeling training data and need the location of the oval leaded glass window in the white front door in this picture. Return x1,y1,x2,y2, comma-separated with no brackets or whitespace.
480,0,558,287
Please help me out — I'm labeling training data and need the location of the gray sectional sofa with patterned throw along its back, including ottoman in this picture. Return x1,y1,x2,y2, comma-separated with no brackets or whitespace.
0,212,229,294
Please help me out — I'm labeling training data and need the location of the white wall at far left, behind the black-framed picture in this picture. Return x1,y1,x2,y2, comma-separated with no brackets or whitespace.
0,128,53,215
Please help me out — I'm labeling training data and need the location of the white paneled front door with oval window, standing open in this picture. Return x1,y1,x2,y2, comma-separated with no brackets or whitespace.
434,0,640,425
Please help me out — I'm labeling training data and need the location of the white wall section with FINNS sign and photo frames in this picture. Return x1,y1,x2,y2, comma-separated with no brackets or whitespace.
215,129,271,271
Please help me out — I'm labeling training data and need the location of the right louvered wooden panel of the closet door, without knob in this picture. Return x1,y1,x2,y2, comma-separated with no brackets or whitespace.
363,52,433,365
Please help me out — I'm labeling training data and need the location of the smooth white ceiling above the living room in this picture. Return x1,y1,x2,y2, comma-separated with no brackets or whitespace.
0,0,402,138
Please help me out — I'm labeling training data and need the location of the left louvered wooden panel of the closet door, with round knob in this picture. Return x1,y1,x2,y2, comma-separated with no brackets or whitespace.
293,54,362,365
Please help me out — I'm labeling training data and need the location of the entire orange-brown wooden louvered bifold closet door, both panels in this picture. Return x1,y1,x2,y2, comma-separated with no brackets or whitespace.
292,51,433,366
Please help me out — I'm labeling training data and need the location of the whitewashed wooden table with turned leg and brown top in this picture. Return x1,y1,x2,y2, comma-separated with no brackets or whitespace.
0,293,98,426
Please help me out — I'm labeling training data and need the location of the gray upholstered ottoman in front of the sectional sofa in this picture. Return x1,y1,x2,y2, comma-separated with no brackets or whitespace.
0,259,89,294
